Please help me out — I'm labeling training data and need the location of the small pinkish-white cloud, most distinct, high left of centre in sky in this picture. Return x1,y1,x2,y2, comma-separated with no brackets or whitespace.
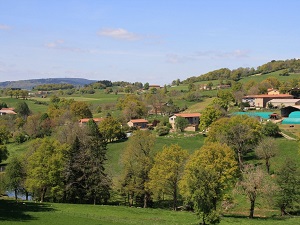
97,28,142,41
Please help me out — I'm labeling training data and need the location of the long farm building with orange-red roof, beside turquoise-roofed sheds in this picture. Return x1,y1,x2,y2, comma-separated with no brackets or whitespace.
242,94,294,108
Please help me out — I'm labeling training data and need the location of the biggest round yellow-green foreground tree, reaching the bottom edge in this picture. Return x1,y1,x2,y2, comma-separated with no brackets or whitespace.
180,143,238,224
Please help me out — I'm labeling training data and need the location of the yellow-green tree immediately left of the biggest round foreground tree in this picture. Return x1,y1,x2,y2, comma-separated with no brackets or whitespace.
147,144,188,210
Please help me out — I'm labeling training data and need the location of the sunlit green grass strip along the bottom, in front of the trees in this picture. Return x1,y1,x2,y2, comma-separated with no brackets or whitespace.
0,199,300,225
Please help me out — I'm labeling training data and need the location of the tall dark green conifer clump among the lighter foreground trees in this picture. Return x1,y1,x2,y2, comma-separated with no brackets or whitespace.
63,119,111,204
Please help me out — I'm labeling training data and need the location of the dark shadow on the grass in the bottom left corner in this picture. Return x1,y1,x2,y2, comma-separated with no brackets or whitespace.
0,199,54,221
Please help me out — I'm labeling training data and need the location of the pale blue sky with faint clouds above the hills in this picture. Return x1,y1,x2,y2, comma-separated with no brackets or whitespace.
0,0,300,85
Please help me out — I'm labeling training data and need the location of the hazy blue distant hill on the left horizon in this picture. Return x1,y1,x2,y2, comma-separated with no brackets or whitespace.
0,78,96,90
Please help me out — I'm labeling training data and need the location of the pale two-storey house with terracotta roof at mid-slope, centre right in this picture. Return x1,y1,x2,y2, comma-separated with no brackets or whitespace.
169,113,201,131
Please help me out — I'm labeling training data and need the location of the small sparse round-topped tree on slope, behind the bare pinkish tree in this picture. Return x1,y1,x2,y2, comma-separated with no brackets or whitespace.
255,137,278,174
